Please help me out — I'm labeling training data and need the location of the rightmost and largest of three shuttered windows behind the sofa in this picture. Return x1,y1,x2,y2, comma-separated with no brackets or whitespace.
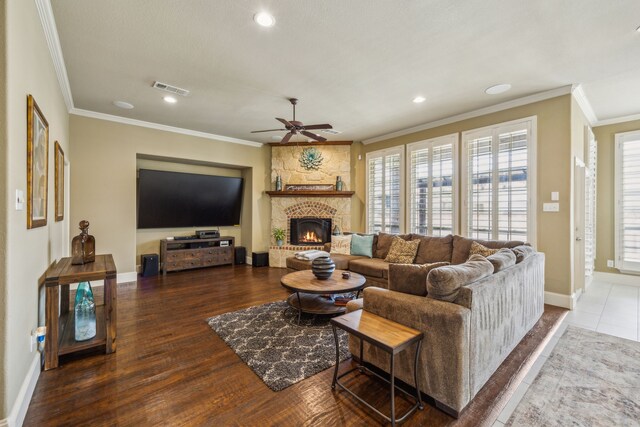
461,117,536,244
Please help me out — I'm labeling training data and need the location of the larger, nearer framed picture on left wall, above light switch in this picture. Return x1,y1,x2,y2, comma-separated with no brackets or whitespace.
27,95,49,228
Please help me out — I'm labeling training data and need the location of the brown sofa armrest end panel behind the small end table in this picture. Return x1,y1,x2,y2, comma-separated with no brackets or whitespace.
364,287,471,411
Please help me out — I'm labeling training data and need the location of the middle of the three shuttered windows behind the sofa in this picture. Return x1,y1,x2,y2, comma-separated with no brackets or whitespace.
407,134,458,236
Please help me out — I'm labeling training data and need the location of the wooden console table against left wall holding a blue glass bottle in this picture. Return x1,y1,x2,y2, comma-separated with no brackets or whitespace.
44,254,117,371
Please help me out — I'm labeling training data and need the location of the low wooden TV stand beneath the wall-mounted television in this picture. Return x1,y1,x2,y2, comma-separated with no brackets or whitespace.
160,236,235,274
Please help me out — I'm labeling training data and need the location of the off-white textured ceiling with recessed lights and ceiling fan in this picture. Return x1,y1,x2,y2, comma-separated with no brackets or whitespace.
52,0,640,142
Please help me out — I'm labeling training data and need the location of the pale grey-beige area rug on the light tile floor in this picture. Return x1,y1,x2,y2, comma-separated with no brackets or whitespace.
507,326,640,427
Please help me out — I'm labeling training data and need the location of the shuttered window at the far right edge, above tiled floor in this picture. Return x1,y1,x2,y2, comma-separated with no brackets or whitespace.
615,131,640,273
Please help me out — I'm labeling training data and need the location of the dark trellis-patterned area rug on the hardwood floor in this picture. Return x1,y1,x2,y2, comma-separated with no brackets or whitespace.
207,301,350,391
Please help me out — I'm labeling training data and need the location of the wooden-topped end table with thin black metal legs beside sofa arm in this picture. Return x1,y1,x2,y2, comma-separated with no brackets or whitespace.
331,310,424,426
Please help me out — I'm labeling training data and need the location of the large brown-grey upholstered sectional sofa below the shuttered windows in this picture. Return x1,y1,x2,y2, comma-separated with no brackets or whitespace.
287,233,544,417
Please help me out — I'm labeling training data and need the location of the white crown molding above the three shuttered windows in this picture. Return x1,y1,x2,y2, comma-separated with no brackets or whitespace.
362,85,572,145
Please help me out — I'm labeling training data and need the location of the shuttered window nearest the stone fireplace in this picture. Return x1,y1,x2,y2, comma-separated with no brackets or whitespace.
366,147,404,234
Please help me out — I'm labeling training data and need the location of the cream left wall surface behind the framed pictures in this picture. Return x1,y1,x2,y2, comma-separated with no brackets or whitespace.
0,0,70,419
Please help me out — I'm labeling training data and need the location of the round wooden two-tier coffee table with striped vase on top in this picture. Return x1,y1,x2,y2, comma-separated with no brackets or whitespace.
280,270,366,324
